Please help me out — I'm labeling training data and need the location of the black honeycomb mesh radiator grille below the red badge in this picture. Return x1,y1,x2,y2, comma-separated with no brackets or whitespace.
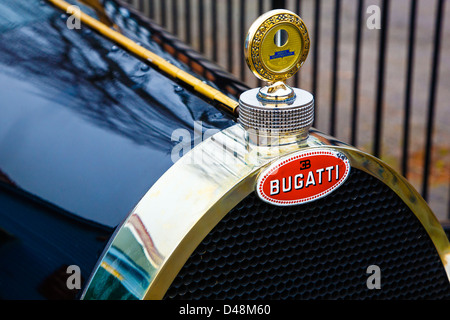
165,168,450,299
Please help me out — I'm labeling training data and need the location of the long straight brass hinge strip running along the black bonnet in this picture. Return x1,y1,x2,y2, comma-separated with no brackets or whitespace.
47,0,239,115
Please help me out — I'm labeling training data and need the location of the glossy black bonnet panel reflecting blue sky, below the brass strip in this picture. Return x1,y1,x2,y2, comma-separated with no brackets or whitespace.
0,0,237,226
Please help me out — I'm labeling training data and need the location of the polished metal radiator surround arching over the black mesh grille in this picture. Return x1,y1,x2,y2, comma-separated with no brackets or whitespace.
82,125,450,299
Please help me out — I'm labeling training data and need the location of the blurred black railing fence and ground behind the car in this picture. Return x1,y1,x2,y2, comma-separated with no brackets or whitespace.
121,0,450,220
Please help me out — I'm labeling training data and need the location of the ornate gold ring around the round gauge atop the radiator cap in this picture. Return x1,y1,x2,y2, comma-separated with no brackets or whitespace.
244,9,310,83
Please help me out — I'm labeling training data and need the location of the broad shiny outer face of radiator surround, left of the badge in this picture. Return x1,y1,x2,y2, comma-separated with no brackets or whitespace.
82,125,265,299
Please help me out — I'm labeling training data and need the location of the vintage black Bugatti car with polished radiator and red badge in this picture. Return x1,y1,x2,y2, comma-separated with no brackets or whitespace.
0,0,450,299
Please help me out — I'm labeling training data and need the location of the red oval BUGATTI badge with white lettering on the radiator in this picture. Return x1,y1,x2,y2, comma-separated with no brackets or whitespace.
256,148,350,206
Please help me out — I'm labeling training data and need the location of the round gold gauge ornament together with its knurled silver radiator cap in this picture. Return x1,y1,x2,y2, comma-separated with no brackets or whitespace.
238,9,314,146
